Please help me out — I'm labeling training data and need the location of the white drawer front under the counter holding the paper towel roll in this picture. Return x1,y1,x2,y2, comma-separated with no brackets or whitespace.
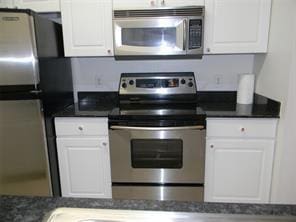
207,118,278,138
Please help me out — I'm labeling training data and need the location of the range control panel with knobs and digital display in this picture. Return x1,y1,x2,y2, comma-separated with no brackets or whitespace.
119,72,196,95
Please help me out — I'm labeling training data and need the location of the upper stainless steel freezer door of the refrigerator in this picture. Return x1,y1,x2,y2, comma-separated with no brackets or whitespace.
0,12,39,86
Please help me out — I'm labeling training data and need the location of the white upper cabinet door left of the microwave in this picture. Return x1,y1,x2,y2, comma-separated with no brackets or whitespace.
61,0,113,56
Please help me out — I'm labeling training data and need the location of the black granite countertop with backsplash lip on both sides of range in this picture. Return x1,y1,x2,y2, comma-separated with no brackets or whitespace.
54,92,280,118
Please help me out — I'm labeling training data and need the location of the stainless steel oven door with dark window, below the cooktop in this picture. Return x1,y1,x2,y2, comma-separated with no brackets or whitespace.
110,126,205,185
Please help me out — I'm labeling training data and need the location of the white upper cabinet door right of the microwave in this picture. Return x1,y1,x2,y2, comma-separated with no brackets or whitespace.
204,0,271,54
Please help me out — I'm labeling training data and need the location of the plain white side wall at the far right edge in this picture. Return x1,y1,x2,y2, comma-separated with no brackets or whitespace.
254,0,296,204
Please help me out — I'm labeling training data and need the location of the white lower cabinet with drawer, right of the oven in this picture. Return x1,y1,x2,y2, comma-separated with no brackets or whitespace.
204,119,277,203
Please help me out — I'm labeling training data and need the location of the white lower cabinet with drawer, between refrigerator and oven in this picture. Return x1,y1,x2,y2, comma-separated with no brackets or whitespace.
55,118,112,198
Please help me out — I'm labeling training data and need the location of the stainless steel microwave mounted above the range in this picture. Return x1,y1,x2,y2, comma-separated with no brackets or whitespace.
113,6,204,59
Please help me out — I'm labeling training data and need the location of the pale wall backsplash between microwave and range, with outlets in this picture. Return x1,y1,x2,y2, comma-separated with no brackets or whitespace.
72,55,254,100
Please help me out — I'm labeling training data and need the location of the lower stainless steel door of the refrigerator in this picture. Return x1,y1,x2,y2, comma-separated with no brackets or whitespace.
0,100,51,196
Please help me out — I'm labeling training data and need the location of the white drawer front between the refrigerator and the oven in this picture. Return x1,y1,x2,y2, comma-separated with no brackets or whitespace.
55,117,108,136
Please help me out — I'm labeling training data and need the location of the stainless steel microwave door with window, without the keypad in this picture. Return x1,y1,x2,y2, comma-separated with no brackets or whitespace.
113,17,187,56
